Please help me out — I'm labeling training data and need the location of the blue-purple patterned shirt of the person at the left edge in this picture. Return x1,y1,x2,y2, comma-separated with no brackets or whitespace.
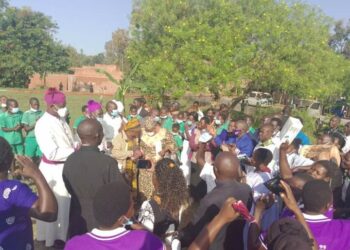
0,180,38,250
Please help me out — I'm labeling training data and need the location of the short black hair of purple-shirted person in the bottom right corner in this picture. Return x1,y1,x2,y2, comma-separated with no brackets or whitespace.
302,180,333,213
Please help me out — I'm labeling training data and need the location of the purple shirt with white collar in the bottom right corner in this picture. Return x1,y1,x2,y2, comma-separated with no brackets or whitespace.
304,214,350,250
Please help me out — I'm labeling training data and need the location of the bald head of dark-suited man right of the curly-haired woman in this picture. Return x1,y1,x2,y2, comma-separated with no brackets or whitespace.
214,152,240,180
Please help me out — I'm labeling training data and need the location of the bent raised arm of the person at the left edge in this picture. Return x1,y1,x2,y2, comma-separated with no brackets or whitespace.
16,156,58,222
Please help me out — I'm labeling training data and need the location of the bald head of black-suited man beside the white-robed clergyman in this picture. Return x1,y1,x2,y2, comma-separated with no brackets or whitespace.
77,119,103,146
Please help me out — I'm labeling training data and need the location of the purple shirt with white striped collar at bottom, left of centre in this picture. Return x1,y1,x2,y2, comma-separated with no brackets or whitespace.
65,228,165,250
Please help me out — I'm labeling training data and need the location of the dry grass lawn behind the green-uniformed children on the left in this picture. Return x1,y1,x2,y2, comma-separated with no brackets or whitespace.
0,89,118,125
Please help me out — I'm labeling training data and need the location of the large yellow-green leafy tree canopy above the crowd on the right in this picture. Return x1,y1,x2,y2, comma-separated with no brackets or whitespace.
128,0,349,101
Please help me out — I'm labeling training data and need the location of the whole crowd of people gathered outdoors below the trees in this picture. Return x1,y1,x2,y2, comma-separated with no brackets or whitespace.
0,89,350,250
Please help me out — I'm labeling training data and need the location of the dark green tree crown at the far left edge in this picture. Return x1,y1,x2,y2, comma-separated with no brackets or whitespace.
0,5,68,87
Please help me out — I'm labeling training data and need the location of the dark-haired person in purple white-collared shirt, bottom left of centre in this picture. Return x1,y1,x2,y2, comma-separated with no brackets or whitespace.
65,182,165,250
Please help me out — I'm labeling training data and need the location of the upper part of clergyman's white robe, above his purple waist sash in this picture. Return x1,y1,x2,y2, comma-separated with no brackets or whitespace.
34,112,74,161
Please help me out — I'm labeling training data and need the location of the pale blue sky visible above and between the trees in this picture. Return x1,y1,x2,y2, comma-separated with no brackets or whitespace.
10,0,350,55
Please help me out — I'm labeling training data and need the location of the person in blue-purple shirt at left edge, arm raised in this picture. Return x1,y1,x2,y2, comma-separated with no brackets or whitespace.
0,137,57,250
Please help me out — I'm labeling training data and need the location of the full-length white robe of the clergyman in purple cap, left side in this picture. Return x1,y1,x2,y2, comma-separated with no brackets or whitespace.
35,112,74,247
